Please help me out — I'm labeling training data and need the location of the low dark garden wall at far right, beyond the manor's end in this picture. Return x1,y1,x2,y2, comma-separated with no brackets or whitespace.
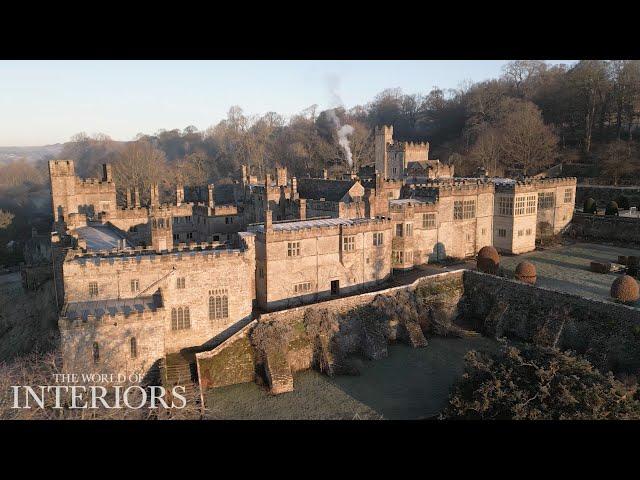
568,212,640,244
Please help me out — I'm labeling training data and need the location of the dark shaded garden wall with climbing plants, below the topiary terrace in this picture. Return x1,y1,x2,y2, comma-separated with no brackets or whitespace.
460,270,640,373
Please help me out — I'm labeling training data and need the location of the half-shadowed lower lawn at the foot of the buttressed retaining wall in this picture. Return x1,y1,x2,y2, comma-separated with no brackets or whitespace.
205,336,497,420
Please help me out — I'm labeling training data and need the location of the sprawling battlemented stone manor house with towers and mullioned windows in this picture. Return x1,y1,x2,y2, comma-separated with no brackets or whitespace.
49,126,576,373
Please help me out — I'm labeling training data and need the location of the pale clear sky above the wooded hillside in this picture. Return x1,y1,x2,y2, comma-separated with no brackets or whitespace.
0,60,572,146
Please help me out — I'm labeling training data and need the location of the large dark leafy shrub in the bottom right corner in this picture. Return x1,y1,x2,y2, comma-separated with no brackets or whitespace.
440,344,640,420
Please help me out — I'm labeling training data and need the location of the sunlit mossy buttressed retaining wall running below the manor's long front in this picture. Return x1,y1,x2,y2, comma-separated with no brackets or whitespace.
196,271,463,400
